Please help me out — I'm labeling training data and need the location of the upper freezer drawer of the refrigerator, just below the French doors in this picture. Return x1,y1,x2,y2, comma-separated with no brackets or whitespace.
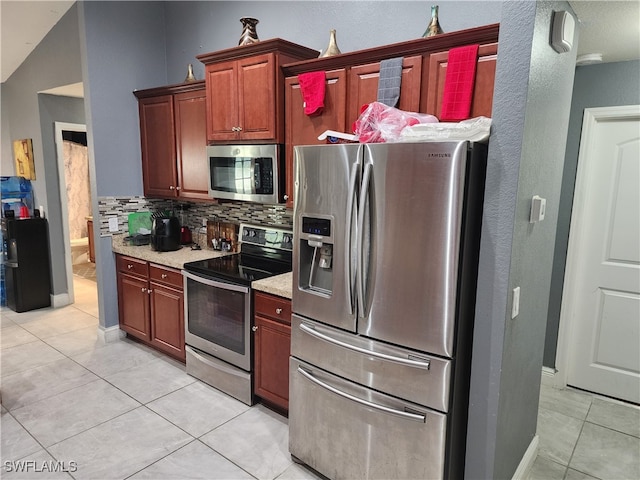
291,314,453,413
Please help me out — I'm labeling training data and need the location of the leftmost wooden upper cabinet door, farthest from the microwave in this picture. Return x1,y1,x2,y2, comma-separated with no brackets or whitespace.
138,95,177,197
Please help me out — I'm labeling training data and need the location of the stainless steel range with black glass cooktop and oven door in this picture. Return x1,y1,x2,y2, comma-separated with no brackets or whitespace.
182,224,292,405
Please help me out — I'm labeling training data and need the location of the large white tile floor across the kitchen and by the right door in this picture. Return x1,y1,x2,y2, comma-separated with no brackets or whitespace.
0,277,640,480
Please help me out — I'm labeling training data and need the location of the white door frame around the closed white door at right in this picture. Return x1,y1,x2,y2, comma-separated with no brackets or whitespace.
553,105,640,388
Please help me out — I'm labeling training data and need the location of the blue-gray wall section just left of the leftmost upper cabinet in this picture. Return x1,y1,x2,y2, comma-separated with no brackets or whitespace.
79,2,167,328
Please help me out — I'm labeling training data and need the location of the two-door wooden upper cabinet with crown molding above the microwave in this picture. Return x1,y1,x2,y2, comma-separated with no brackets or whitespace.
197,38,318,143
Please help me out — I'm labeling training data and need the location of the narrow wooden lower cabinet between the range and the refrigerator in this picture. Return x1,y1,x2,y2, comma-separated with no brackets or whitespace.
253,292,291,412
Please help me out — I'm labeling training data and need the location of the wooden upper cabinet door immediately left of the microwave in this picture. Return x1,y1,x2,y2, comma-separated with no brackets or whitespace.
174,88,210,200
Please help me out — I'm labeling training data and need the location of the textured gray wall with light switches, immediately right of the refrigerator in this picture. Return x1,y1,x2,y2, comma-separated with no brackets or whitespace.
466,2,577,479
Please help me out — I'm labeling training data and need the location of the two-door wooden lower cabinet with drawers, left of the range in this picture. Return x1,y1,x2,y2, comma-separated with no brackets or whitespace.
116,255,185,362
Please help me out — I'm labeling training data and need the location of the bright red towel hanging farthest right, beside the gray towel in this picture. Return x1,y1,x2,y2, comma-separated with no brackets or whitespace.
440,45,478,122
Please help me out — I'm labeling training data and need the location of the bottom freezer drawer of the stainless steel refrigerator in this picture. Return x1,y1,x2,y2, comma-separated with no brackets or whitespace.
289,357,447,480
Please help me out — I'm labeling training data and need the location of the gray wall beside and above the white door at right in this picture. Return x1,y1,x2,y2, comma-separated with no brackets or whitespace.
544,60,640,368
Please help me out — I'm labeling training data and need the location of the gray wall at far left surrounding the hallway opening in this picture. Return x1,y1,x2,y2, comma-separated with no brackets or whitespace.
2,6,85,294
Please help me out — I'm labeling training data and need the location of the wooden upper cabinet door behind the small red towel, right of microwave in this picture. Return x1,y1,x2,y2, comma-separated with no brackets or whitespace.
285,68,347,208
